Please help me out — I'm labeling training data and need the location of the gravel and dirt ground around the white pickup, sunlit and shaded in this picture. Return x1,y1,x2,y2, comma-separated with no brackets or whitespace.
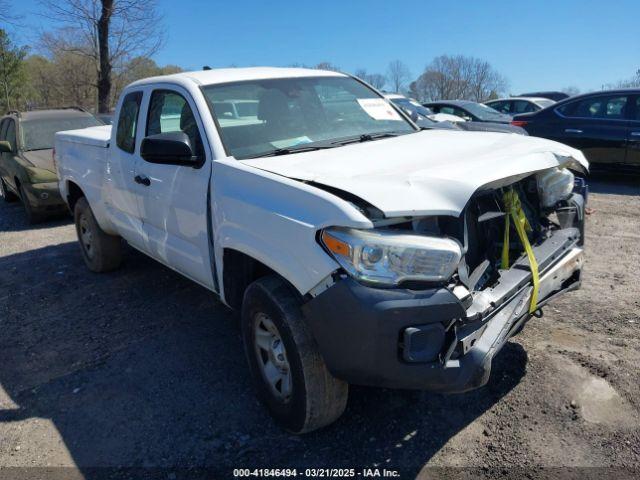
0,173,640,479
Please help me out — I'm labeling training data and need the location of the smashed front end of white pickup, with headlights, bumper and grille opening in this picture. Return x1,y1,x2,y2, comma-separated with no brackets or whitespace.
304,168,585,392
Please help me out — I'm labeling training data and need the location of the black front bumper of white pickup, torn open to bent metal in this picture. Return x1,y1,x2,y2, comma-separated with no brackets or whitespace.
303,228,583,392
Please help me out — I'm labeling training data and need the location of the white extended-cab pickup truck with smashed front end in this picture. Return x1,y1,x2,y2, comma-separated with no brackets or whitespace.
56,68,588,433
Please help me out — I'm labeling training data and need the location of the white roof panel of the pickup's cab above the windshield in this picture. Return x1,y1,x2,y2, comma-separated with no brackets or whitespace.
131,67,346,85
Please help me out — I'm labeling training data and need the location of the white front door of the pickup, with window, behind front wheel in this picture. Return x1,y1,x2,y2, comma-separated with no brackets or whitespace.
136,86,213,288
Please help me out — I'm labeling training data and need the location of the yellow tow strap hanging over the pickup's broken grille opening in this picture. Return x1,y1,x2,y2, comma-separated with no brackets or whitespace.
502,189,540,313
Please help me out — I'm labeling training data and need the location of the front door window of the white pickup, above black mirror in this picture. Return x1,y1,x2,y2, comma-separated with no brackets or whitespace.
147,90,203,155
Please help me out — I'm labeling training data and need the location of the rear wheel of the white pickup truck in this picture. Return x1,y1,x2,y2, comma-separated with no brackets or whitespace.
73,197,122,273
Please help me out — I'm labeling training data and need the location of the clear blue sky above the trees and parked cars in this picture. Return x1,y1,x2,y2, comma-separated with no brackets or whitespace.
12,0,640,93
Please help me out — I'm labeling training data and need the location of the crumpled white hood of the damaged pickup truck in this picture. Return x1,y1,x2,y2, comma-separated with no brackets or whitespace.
242,129,589,217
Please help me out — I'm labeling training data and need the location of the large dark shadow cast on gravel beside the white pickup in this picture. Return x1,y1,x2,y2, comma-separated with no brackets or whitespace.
0,236,527,474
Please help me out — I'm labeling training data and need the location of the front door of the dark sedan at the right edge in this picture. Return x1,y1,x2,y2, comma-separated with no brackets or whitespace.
550,93,629,164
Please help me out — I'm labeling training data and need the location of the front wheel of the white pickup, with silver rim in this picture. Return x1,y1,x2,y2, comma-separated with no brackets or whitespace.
241,275,349,434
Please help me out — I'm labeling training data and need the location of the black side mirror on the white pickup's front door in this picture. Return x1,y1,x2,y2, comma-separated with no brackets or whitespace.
140,132,202,168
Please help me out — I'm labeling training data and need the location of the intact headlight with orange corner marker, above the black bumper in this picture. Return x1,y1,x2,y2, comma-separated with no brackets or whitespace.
321,228,462,286
